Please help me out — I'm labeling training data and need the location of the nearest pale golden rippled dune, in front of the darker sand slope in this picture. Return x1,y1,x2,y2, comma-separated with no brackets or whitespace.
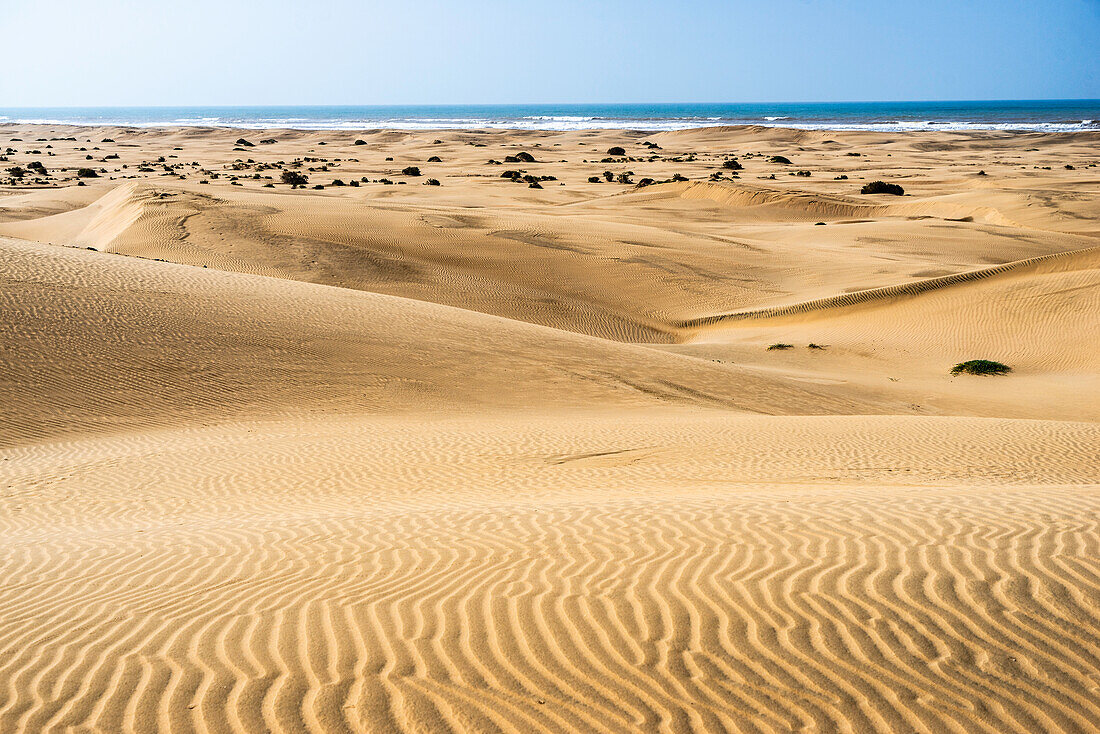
0,415,1100,733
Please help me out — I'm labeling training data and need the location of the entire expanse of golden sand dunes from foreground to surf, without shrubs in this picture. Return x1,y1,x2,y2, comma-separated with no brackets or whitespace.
0,125,1100,734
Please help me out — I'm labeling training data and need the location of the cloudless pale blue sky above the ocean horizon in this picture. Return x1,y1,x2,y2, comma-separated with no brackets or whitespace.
0,0,1100,107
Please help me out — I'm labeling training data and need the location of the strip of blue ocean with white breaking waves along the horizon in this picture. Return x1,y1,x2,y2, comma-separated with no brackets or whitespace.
0,99,1100,132
